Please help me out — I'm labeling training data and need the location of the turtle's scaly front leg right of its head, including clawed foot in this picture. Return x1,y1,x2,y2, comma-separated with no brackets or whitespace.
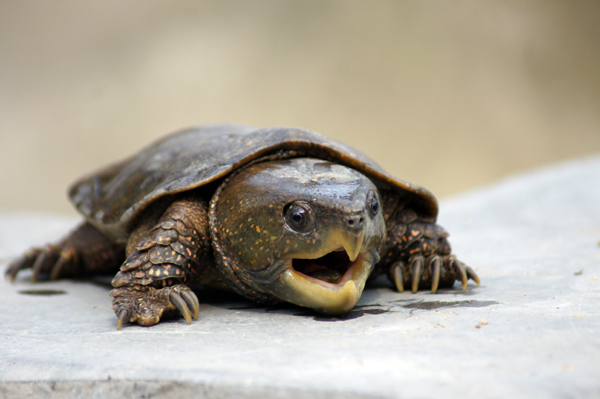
382,197,479,293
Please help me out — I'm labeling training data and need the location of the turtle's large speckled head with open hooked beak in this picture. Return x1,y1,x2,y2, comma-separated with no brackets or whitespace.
212,158,386,314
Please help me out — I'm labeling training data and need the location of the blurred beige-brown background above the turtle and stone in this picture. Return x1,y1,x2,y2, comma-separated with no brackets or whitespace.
0,0,600,219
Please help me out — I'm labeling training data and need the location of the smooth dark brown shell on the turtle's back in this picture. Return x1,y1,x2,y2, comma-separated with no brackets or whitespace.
69,125,438,240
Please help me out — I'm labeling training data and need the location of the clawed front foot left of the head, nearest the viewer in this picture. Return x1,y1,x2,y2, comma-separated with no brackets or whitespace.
110,284,200,330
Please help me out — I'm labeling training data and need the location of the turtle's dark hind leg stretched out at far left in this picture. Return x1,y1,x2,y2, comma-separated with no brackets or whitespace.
5,222,125,283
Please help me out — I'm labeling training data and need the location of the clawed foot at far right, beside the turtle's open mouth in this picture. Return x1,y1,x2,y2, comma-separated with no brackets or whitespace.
389,255,479,294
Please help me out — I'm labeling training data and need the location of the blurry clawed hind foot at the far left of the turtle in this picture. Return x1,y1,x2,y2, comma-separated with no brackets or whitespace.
5,244,77,283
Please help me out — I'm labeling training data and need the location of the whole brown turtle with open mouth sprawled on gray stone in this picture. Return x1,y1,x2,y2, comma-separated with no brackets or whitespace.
6,124,479,329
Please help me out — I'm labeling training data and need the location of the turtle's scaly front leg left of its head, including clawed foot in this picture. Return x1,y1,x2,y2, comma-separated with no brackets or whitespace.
110,196,213,329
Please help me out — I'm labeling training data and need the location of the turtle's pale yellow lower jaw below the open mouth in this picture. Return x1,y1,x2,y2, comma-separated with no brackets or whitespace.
262,252,376,315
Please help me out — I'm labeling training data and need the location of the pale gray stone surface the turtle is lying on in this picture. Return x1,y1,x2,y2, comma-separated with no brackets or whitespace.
0,157,600,398
